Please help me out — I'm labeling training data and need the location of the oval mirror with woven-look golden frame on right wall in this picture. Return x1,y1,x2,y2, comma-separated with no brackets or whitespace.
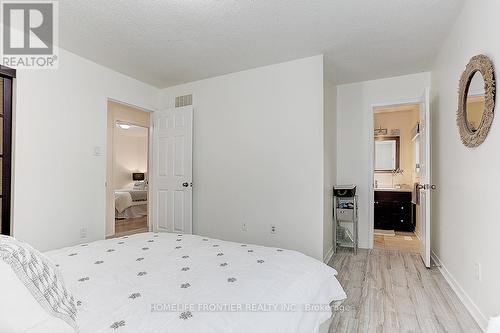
457,55,496,147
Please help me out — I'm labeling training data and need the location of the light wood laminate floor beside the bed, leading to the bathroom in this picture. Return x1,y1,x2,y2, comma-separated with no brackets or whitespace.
329,249,481,333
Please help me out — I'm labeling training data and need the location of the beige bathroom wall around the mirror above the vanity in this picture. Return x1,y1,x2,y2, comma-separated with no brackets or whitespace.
373,107,419,187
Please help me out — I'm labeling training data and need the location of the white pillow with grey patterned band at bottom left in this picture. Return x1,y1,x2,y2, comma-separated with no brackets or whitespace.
0,236,78,333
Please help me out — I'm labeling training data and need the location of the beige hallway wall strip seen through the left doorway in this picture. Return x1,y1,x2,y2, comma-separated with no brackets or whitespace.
106,101,149,236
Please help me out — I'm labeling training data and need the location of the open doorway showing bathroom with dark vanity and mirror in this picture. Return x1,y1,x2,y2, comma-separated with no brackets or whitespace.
373,104,421,252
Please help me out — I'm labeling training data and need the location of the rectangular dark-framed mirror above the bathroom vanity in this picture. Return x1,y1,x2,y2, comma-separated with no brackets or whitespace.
374,136,399,172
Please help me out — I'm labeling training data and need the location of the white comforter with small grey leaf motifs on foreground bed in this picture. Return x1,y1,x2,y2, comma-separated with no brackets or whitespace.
46,233,346,333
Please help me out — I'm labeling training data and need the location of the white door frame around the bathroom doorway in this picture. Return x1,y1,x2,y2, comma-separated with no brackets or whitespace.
367,98,422,249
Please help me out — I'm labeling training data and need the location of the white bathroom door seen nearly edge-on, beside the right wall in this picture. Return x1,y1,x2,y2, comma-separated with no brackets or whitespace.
419,88,434,267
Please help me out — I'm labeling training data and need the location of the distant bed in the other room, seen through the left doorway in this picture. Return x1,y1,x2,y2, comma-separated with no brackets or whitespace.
115,190,148,219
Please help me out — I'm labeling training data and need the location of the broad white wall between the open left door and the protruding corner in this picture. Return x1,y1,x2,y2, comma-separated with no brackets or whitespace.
161,56,323,260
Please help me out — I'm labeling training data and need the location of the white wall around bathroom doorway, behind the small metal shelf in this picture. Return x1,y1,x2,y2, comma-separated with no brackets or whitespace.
337,72,431,248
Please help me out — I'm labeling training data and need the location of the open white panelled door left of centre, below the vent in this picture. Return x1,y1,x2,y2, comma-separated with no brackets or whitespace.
151,106,193,234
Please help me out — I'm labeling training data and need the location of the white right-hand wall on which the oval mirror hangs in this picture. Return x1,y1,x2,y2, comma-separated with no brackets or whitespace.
432,0,500,326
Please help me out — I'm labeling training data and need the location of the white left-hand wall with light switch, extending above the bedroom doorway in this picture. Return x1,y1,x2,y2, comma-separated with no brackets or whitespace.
13,50,158,251
